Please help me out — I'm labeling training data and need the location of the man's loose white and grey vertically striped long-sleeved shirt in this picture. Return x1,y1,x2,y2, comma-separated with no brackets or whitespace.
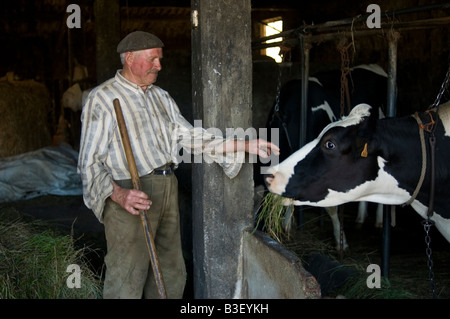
78,70,244,222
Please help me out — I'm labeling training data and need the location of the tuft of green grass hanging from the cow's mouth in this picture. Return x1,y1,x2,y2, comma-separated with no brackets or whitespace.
255,193,294,243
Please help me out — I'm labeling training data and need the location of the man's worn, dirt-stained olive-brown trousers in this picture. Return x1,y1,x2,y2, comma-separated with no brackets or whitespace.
103,174,186,299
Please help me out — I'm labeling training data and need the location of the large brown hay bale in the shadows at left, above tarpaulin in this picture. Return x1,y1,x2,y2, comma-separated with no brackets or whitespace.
0,81,51,158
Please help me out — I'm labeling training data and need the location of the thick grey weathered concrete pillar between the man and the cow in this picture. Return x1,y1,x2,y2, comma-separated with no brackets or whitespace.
191,0,253,298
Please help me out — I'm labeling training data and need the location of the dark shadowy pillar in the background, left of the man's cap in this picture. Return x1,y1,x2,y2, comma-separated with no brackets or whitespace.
94,0,121,84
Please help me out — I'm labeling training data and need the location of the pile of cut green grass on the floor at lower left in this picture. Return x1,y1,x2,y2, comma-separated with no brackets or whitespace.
0,208,102,299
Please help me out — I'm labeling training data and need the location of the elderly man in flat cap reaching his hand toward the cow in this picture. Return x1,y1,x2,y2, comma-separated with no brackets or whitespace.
78,31,279,298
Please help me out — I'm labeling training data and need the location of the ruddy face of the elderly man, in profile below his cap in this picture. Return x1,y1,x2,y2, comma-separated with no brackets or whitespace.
130,48,163,86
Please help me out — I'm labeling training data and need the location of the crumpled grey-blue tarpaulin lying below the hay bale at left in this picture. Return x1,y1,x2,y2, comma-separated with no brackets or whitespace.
0,143,83,203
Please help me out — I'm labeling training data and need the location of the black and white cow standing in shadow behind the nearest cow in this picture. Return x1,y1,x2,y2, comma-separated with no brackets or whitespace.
267,64,387,249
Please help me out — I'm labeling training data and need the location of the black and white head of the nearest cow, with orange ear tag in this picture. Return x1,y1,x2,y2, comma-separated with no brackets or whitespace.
266,104,383,207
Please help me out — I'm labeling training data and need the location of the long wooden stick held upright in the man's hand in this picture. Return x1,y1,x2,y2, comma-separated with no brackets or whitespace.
113,99,167,299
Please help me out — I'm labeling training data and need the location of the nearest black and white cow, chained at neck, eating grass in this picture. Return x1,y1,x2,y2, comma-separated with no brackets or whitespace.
267,102,450,242
